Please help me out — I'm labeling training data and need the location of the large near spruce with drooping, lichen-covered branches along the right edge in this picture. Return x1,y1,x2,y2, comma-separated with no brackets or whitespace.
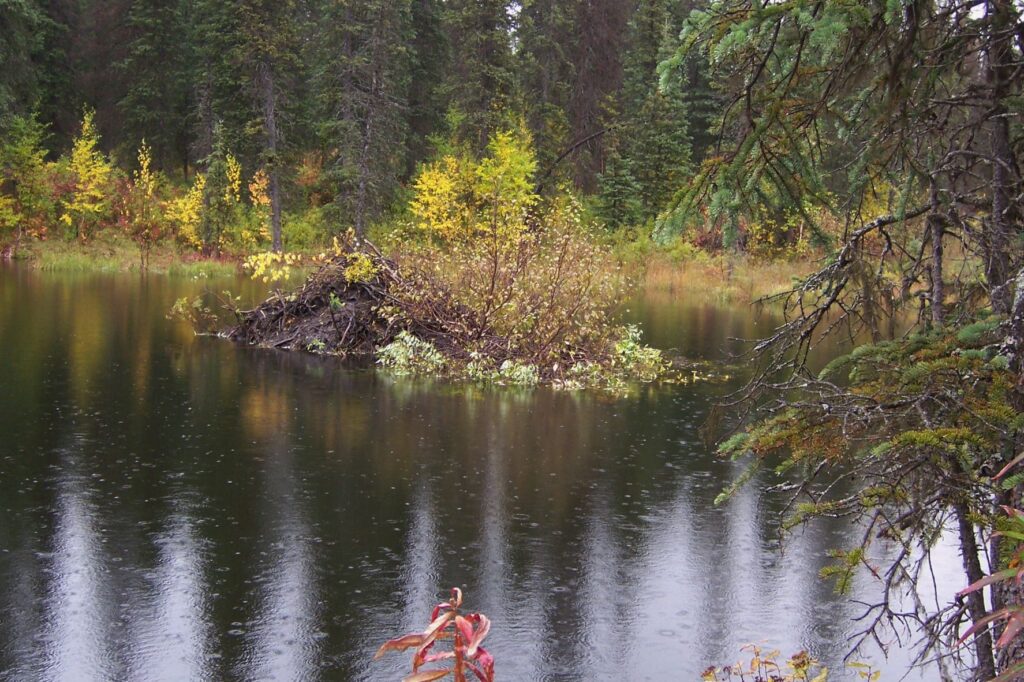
662,0,1024,680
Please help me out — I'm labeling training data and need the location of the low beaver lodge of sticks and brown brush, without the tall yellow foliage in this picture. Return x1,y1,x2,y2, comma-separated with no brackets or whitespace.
222,243,666,385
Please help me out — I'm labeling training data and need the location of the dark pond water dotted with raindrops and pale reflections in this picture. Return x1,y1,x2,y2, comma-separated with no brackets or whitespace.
0,269,956,680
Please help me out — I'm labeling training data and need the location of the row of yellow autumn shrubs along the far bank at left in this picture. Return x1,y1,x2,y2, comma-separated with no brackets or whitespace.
0,110,280,261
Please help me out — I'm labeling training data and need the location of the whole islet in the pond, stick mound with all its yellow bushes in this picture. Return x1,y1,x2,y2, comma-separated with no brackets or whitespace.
229,133,665,387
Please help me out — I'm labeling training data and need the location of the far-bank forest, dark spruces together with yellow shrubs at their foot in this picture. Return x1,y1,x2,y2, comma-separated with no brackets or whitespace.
0,0,718,252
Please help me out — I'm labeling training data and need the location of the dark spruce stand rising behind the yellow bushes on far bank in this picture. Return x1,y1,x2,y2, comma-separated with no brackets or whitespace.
0,0,714,244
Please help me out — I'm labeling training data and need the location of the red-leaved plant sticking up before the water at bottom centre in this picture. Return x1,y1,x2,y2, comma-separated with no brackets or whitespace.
374,588,495,682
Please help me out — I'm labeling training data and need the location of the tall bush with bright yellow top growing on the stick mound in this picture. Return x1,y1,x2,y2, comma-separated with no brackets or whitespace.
397,147,624,367
